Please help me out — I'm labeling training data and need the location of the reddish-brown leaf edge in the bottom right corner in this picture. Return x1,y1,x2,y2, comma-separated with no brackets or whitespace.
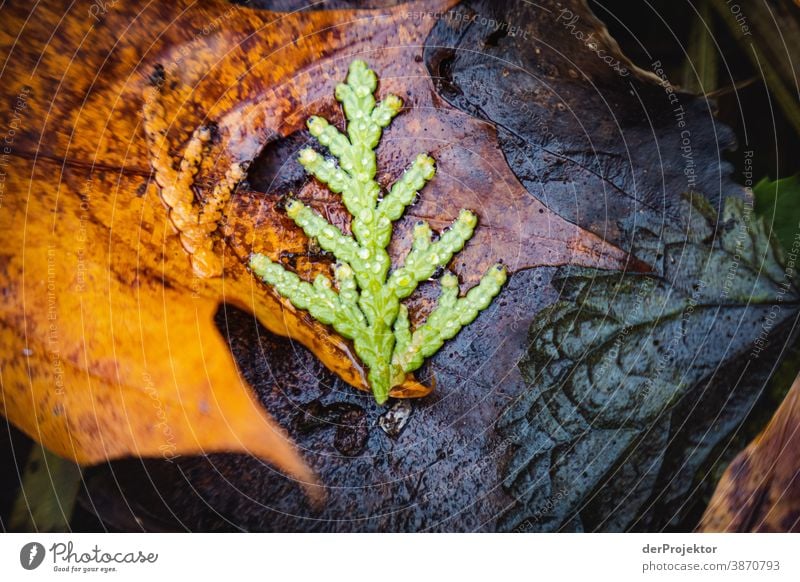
698,376,800,532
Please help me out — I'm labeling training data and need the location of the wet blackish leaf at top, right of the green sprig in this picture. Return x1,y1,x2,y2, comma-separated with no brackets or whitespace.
426,1,739,249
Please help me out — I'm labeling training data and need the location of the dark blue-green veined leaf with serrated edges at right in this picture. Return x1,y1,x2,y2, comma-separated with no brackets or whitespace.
499,199,800,531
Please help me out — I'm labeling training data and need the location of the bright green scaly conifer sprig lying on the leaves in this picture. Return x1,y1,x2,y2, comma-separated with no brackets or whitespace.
250,61,506,404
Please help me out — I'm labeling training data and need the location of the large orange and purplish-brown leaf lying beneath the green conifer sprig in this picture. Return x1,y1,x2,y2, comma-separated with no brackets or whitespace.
0,0,628,483
